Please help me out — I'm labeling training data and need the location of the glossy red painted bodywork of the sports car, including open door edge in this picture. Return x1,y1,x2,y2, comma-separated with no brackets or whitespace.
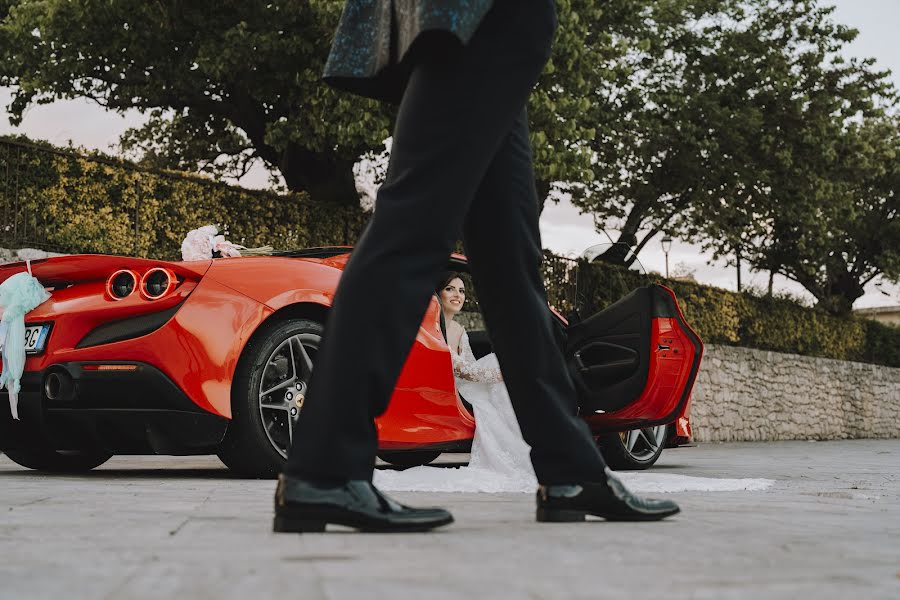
0,249,694,458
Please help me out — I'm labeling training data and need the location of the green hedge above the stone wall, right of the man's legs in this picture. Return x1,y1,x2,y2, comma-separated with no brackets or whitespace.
544,255,900,367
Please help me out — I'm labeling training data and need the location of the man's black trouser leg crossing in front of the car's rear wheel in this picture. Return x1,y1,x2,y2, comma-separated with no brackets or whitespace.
285,0,555,480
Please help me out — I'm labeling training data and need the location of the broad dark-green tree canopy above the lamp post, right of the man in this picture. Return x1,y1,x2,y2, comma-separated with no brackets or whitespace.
574,0,897,313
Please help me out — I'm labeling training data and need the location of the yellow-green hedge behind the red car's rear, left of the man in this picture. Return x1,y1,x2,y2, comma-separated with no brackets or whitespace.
0,138,368,259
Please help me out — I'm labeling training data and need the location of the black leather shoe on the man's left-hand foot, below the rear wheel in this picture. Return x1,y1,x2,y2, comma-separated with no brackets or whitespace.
273,473,453,533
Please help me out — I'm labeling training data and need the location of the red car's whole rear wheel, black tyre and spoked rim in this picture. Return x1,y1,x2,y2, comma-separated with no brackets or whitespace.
217,319,323,479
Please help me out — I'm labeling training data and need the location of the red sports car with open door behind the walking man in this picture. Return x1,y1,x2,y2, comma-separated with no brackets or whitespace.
0,247,703,477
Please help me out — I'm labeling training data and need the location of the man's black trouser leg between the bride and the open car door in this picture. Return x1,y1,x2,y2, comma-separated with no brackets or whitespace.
464,111,606,485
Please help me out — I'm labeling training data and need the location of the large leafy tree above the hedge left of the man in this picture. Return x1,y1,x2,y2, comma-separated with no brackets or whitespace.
0,0,390,204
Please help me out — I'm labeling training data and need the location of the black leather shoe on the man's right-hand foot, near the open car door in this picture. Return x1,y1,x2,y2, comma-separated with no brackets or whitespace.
537,469,681,523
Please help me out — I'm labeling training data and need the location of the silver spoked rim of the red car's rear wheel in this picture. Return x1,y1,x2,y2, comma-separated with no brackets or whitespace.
259,333,321,458
